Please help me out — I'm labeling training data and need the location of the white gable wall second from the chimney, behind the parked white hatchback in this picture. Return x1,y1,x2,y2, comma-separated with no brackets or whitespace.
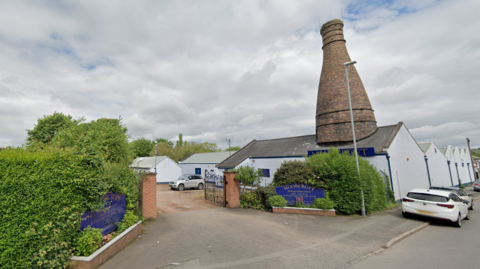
425,144,452,186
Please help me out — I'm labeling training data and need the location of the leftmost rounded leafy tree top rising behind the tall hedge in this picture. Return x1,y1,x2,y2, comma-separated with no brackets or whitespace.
27,112,83,145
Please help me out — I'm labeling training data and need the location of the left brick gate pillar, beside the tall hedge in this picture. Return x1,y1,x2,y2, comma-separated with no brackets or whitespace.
142,172,157,220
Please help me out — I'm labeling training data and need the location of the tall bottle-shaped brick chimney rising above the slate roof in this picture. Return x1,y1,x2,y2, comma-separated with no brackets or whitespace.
316,19,377,145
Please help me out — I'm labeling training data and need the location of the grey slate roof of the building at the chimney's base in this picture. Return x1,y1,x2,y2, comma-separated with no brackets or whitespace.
218,122,403,168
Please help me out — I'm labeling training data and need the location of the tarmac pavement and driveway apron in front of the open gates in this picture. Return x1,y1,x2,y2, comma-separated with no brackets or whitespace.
100,185,480,269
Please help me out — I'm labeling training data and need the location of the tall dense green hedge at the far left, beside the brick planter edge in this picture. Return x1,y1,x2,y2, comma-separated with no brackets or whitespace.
0,148,139,268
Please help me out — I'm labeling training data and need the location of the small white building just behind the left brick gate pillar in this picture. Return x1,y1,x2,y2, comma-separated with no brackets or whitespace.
129,156,182,184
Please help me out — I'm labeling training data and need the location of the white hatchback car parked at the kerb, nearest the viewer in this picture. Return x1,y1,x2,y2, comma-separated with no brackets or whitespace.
402,189,470,227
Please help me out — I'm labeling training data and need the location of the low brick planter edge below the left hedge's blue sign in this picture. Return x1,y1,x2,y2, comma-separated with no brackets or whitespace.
67,221,142,269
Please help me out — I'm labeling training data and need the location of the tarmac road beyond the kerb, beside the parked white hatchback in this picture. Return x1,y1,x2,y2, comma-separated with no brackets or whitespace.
349,195,480,269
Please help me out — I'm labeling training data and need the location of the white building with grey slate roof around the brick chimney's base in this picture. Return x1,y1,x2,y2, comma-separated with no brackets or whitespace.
218,122,429,200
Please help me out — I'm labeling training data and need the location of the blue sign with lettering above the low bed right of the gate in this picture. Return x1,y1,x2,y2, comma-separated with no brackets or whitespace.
275,184,325,205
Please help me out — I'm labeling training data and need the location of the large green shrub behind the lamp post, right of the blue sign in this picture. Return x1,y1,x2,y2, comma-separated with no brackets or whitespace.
306,148,387,215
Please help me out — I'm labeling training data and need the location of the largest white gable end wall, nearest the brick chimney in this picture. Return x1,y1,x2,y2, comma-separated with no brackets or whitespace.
388,125,429,200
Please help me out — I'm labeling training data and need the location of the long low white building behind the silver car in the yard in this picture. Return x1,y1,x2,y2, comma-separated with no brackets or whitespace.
179,151,236,177
